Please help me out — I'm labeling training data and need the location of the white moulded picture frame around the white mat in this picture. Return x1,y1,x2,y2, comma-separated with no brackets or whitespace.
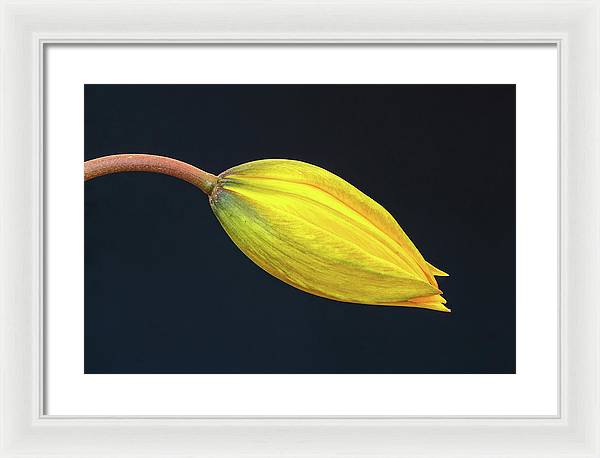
0,0,600,457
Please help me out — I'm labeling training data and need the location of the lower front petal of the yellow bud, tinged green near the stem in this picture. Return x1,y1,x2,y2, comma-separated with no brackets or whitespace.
211,189,440,304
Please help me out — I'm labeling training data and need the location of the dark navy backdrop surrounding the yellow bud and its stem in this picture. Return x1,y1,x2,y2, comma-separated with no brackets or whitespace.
85,85,515,373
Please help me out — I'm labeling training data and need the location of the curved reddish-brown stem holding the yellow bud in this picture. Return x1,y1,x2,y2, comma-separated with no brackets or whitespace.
84,154,217,195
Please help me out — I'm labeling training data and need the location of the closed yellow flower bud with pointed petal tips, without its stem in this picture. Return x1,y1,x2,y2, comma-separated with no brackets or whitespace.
210,159,450,312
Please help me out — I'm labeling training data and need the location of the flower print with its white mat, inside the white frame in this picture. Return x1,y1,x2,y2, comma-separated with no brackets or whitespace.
44,44,559,416
